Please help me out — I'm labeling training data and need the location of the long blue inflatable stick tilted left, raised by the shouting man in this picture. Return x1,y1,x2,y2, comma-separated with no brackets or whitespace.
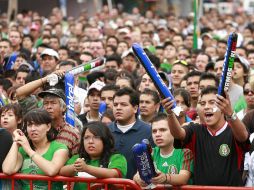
132,43,181,115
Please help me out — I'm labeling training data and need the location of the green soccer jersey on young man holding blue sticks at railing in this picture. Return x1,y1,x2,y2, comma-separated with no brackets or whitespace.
152,147,194,184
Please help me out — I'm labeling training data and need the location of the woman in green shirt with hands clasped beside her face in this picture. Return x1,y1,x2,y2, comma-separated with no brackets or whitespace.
2,109,68,190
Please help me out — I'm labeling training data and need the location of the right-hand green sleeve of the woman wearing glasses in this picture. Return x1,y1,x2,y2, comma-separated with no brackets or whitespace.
108,154,127,178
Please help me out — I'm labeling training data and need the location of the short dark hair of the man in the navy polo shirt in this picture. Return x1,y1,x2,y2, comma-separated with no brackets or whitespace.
113,87,139,107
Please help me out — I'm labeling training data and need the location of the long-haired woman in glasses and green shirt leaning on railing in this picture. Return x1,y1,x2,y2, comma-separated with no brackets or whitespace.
60,122,127,190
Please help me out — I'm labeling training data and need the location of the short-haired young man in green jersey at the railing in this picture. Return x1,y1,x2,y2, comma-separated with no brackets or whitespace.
133,113,193,186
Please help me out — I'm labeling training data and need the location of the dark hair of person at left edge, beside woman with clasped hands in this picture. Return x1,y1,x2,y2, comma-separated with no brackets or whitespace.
0,103,23,129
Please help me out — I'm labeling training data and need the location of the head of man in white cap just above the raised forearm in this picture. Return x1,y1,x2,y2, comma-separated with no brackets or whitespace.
41,48,59,74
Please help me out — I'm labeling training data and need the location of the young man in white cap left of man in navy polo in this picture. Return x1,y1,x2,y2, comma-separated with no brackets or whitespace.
78,81,105,125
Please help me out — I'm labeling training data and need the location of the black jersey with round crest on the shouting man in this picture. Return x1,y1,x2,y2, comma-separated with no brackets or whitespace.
175,123,249,186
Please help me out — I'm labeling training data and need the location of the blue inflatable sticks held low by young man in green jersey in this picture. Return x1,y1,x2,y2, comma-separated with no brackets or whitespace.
132,139,157,185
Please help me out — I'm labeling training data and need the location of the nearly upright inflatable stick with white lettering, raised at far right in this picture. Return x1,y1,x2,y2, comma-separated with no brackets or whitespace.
218,33,237,97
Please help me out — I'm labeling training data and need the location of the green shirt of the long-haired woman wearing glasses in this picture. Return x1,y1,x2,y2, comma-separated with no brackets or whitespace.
66,154,127,190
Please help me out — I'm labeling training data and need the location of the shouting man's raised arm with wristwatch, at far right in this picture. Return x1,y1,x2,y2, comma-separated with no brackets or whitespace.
216,92,249,142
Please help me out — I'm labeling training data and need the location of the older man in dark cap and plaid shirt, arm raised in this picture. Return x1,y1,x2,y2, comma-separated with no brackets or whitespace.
16,70,80,155
